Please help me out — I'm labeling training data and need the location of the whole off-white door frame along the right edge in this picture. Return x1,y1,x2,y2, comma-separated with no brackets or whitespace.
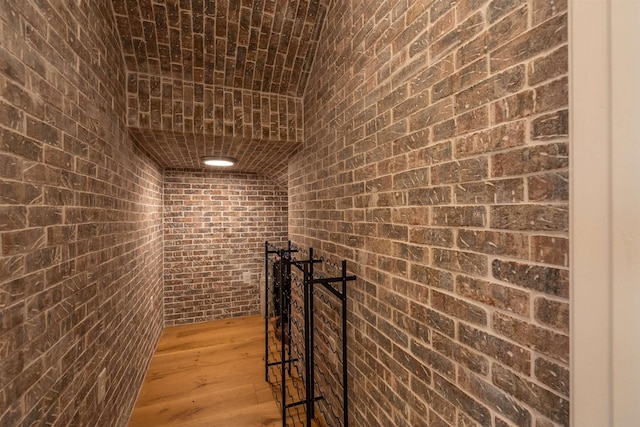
569,0,640,427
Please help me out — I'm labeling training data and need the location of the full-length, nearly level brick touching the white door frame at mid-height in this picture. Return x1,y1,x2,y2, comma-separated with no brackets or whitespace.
490,205,569,231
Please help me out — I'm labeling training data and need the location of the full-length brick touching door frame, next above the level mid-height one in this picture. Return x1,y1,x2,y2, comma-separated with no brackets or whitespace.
491,143,569,177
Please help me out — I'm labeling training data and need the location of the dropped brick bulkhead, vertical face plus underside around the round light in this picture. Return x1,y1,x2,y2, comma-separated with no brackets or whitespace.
127,77,303,186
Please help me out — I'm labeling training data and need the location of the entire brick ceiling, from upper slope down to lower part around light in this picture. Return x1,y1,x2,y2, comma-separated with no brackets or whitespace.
112,0,328,182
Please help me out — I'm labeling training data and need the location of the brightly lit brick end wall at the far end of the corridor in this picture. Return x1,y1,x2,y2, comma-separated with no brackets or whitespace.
164,171,287,325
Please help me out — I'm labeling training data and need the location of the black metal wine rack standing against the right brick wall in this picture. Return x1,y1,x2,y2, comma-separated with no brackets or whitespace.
264,242,356,427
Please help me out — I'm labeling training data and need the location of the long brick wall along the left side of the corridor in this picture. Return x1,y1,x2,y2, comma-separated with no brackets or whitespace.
0,0,162,426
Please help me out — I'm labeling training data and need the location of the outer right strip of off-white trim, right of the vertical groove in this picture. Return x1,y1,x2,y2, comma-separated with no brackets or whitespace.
610,0,640,427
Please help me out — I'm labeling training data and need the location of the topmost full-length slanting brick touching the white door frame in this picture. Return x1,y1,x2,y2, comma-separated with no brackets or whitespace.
490,14,568,72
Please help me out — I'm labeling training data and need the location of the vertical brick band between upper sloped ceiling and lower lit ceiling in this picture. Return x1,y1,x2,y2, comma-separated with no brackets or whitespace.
127,73,303,141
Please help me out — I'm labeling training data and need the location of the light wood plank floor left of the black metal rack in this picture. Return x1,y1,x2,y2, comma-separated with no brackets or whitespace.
129,316,282,427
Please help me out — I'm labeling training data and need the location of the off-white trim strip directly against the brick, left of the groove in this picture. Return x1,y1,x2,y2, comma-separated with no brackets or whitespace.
569,0,612,427
